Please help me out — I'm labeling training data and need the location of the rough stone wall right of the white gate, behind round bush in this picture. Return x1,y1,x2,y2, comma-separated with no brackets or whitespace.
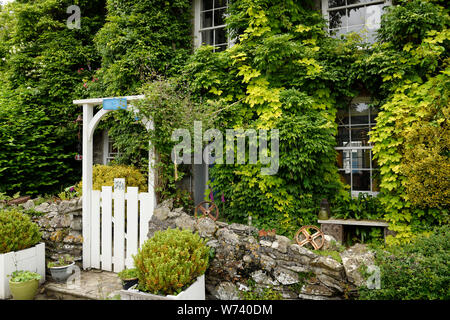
148,201,373,300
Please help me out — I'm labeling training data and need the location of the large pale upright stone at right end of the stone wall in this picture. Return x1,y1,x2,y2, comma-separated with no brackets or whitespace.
341,243,375,287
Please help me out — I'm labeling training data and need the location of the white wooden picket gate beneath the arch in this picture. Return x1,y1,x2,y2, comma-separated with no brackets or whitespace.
90,187,154,272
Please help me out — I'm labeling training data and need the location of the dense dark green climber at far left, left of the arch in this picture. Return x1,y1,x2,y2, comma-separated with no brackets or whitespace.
0,0,105,194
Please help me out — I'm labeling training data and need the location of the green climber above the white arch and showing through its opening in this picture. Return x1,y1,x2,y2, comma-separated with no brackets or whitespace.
85,0,193,172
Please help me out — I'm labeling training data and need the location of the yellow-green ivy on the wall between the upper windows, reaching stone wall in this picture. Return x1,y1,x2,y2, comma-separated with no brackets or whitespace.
179,0,351,236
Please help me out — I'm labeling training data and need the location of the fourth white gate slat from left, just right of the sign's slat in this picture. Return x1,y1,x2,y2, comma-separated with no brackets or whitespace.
125,187,139,268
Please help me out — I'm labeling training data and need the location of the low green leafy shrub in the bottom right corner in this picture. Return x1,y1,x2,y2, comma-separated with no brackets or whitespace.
360,225,450,300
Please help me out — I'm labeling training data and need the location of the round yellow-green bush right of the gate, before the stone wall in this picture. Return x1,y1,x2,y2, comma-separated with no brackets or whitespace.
133,229,209,295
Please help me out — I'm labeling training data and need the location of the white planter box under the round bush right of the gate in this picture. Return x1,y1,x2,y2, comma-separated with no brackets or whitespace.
120,274,205,300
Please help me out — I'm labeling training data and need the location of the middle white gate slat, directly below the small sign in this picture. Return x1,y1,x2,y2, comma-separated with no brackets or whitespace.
113,190,125,272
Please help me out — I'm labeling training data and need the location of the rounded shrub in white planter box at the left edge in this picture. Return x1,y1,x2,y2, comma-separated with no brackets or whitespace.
0,209,45,299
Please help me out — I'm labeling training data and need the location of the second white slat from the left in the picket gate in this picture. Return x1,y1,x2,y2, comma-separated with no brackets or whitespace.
102,186,112,271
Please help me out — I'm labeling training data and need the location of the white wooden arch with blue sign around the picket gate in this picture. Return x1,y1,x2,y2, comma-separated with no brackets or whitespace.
73,95,156,269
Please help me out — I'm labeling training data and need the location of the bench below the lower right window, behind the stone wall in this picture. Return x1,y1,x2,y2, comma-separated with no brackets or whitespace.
318,217,395,244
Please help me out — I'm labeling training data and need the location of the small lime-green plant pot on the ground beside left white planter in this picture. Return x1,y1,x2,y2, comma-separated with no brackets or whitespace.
9,270,42,300
